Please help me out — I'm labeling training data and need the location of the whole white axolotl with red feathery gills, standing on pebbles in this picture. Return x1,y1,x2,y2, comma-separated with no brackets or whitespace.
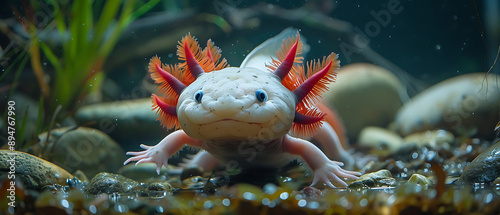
124,29,360,187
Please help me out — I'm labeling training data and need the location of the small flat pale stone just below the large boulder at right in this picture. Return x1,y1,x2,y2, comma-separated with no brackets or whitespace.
403,130,456,148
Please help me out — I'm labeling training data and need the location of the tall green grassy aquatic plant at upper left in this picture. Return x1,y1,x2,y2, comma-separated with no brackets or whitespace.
29,0,159,114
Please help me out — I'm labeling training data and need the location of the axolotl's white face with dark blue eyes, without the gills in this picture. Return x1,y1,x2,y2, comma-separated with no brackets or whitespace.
177,67,296,140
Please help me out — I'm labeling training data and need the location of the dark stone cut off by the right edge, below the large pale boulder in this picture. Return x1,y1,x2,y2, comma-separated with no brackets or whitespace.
458,140,500,184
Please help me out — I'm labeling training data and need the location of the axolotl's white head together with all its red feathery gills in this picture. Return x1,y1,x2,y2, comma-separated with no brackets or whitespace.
149,35,338,141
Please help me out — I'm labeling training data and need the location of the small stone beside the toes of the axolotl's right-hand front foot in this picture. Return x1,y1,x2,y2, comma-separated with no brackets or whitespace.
347,169,396,189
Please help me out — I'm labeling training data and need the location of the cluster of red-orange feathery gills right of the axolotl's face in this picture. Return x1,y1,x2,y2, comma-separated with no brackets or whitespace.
269,34,339,137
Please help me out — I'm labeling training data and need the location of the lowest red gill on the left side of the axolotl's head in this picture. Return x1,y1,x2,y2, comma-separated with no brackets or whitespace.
151,94,180,129
